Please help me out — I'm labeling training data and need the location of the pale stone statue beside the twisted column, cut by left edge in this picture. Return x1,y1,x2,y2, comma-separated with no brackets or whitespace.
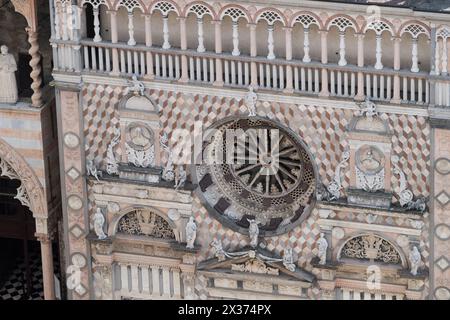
0,46,18,103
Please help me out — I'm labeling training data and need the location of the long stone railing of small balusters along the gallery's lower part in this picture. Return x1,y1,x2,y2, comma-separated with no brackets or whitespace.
72,40,438,105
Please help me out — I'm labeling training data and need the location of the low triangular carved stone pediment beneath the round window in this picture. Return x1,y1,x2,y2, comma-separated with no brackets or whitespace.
198,248,315,282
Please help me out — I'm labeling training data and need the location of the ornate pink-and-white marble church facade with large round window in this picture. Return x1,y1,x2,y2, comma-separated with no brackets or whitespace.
0,0,450,300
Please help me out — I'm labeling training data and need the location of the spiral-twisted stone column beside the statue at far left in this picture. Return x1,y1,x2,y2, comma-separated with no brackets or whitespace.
26,28,42,108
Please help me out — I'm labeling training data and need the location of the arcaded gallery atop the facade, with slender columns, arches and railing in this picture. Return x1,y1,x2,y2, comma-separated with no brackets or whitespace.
52,0,450,105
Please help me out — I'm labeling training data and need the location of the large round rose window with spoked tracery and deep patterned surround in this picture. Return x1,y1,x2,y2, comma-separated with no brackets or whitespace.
194,117,316,235
